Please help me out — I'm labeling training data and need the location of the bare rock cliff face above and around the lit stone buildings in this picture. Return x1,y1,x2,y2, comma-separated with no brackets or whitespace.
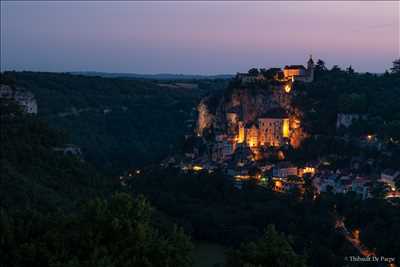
196,81,304,150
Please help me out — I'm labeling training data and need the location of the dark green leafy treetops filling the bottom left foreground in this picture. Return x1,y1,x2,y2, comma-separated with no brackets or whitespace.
0,193,192,267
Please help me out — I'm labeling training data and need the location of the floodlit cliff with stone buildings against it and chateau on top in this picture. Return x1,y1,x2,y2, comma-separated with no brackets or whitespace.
196,56,314,162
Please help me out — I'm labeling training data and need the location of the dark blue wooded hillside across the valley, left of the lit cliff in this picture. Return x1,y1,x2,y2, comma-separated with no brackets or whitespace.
3,72,228,174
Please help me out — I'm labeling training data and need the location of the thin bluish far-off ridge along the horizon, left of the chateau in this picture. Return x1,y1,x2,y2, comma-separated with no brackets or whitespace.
70,71,234,80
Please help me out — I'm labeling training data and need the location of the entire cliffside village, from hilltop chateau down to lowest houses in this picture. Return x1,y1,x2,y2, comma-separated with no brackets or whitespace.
162,56,400,202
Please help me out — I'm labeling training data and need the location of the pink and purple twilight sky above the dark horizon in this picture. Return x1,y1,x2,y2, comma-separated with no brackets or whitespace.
1,1,400,74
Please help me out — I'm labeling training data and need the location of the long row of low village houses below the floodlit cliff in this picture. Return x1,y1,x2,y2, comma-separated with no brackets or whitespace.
177,154,400,199
